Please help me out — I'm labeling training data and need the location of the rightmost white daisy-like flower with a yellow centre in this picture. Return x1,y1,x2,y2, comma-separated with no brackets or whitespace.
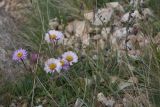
62,51,78,65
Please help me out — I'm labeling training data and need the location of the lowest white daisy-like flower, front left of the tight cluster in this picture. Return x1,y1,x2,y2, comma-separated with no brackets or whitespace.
44,58,62,73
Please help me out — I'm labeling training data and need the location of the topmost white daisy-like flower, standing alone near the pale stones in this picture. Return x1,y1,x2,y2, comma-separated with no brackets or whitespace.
45,30,63,43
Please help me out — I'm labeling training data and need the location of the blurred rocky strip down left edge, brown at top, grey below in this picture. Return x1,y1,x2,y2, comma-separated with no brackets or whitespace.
0,0,31,93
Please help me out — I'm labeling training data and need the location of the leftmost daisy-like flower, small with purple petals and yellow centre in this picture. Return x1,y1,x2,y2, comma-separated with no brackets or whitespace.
12,48,27,61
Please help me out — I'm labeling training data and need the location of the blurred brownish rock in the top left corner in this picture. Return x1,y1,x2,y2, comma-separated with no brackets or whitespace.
4,0,33,25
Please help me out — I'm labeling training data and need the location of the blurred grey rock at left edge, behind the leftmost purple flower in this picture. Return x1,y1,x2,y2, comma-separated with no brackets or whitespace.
0,9,24,85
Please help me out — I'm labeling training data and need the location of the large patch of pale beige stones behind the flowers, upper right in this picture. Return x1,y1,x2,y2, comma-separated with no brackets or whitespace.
49,2,159,58
